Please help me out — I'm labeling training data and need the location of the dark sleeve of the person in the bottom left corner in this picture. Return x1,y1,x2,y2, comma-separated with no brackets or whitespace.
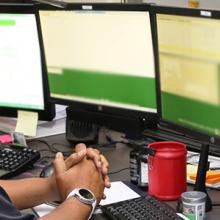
0,187,37,220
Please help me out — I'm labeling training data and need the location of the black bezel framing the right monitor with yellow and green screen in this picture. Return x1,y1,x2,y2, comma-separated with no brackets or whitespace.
152,6,220,145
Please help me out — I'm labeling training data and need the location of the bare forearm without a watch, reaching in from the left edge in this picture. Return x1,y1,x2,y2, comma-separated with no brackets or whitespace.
0,178,54,209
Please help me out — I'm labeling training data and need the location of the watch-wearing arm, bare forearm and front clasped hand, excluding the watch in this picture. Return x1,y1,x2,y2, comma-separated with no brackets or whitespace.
40,154,104,220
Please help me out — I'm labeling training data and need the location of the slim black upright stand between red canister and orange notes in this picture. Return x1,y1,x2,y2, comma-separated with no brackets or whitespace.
194,143,212,212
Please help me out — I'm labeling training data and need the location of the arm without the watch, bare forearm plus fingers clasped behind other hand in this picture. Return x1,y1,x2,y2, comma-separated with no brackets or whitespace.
0,144,109,209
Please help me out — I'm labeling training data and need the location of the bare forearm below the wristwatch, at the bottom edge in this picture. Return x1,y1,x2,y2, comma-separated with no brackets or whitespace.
39,197,92,220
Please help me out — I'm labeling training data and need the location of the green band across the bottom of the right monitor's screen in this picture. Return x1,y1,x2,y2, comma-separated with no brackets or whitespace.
161,92,220,135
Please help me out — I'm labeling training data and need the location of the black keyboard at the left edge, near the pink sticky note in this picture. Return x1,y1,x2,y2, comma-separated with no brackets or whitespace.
0,144,40,179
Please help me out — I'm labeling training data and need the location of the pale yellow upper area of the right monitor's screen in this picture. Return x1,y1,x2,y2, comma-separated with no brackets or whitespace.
157,14,220,105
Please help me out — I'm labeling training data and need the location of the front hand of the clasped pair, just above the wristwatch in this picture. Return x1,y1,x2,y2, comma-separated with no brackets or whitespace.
54,150,104,203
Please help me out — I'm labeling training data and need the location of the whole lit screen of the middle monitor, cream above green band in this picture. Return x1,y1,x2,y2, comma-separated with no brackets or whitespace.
40,10,156,112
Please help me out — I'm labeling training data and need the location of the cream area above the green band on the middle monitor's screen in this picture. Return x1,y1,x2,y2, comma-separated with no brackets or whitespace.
40,11,155,77
